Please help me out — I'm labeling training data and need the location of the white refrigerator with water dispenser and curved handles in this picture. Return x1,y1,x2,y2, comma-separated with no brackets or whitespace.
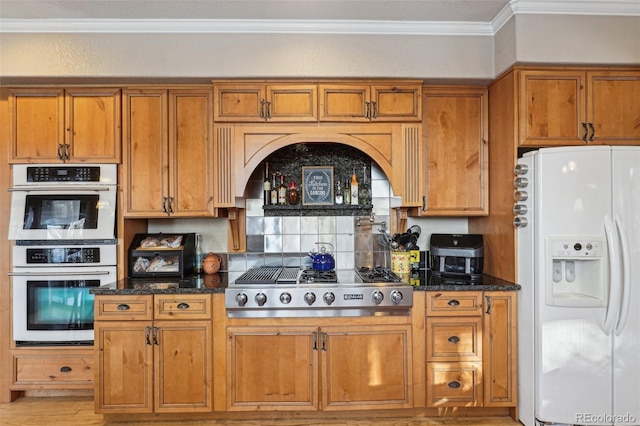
514,146,640,426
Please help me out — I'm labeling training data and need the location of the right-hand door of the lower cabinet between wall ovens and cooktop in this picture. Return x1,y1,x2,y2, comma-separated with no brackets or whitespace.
154,320,213,413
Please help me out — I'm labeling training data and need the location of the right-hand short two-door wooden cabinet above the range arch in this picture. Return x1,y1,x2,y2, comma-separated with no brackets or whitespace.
319,81,422,122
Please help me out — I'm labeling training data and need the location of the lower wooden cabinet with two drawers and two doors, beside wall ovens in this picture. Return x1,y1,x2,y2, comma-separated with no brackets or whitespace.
94,294,213,413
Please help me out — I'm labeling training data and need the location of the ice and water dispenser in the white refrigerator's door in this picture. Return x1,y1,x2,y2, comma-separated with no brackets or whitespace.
545,237,609,307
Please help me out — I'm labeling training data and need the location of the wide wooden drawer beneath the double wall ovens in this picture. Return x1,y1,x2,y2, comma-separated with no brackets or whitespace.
13,354,94,389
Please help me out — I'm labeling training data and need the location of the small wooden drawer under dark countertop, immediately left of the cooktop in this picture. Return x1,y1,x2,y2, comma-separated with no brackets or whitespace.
154,294,211,320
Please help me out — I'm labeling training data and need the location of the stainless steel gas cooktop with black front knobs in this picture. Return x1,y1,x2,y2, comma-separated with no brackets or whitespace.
225,267,413,317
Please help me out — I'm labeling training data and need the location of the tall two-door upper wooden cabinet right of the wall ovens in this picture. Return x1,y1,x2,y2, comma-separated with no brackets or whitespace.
123,88,215,218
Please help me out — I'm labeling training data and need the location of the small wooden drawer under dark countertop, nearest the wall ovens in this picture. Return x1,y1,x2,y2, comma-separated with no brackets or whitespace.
95,295,153,321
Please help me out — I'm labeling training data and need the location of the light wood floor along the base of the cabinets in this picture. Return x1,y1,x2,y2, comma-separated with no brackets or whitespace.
0,396,521,426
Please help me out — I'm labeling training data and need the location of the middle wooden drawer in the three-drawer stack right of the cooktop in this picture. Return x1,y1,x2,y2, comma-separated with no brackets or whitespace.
427,317,482,361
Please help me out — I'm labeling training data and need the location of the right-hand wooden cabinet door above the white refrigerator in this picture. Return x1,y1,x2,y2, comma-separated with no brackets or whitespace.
587,70,640,145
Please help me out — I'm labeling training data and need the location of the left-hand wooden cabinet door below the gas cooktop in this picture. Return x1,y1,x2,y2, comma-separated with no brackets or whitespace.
227,326,319,411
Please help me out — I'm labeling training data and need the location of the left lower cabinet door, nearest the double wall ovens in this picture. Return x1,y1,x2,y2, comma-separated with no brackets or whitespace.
94,321,153,413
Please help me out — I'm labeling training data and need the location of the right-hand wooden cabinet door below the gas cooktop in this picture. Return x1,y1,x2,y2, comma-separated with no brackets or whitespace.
320,325,413,411
